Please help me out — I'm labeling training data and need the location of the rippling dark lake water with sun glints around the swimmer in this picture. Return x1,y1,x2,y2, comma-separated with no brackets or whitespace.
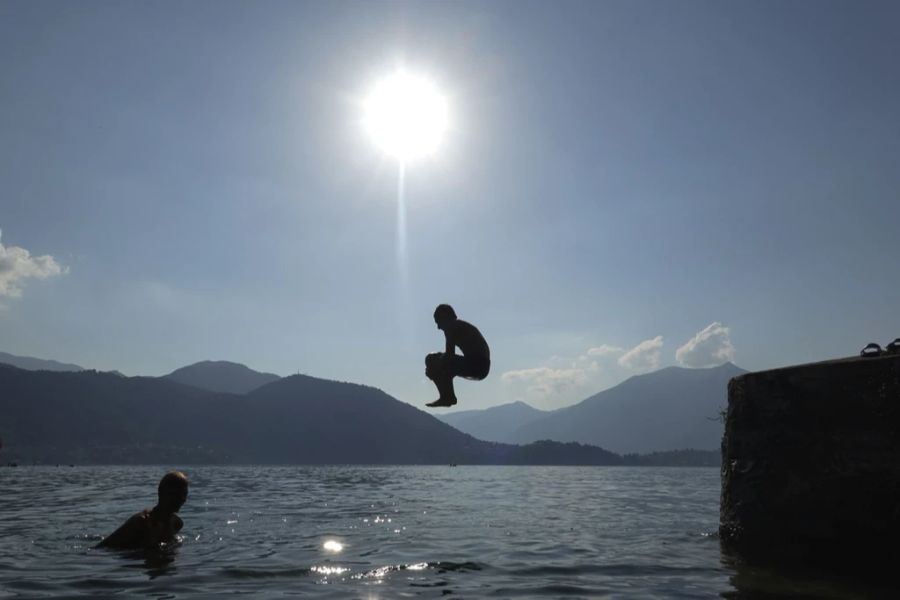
0,466,896,598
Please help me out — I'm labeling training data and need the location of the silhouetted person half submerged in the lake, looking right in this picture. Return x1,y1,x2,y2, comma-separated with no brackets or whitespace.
97,471,188,548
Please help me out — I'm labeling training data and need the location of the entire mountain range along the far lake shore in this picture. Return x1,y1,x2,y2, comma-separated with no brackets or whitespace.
0,354,745,464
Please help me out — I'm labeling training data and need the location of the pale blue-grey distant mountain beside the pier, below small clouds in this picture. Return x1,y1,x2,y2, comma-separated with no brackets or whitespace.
506,363,746,454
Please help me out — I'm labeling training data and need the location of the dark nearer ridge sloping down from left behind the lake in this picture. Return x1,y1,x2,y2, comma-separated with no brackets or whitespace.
0,365,624,465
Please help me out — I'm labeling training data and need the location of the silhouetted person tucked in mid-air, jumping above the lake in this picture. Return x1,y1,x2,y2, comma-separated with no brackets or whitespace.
425,304,491,406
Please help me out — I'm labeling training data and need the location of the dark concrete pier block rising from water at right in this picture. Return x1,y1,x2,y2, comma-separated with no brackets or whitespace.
719,355,900,568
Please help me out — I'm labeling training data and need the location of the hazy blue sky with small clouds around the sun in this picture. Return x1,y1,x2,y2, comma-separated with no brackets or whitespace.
0,0,900,409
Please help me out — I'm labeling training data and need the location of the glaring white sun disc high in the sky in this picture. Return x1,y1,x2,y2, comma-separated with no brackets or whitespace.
364,71,447,163
